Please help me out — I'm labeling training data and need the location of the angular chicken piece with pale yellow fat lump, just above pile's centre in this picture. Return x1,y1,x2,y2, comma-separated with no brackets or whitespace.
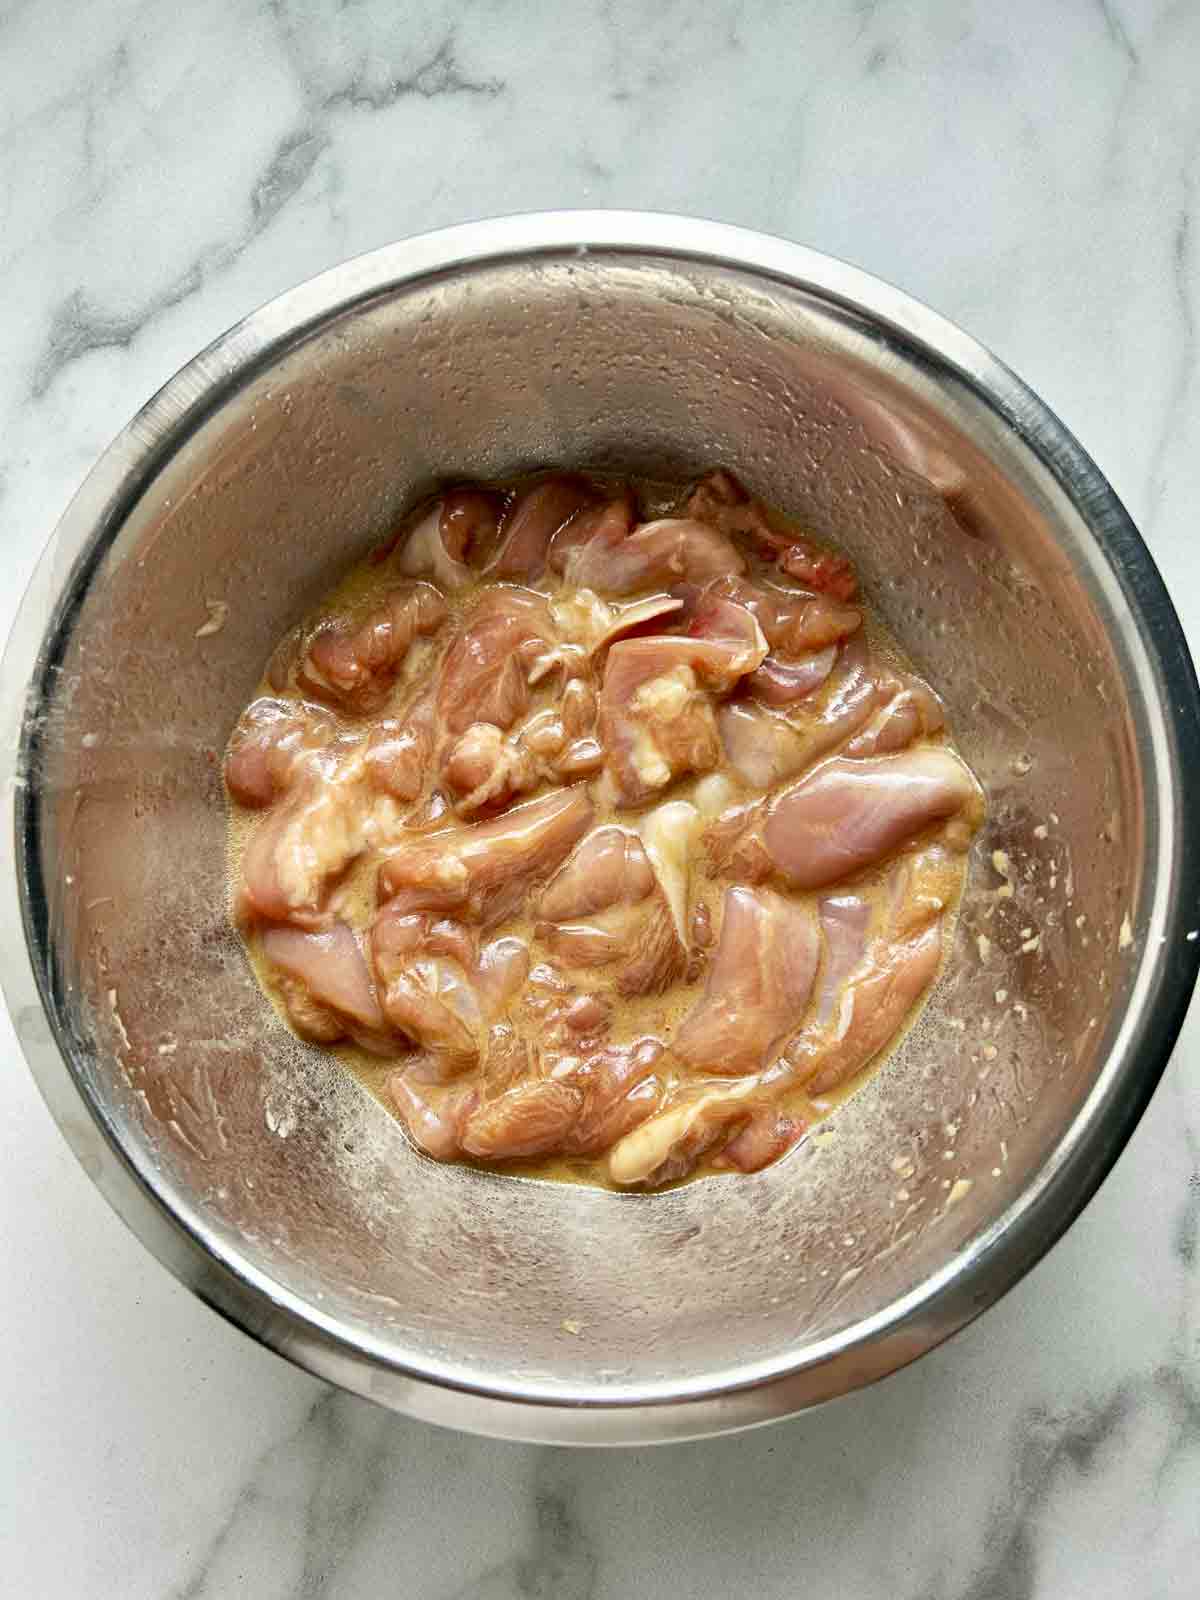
600,634,762,805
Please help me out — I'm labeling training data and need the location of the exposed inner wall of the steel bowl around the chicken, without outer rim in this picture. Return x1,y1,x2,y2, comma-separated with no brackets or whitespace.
14,250,1158,1420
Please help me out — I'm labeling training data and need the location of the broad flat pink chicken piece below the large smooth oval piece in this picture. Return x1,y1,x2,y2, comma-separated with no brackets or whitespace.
674,886,821,1077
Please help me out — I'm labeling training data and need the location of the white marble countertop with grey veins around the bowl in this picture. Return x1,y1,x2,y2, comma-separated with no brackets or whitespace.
0,0,1200,1600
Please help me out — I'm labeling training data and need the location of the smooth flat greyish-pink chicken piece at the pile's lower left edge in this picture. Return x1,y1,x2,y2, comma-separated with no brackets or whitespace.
262,922,398,1054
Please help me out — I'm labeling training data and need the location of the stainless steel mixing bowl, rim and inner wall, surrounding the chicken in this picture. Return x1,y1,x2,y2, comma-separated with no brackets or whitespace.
3,213,1200,1442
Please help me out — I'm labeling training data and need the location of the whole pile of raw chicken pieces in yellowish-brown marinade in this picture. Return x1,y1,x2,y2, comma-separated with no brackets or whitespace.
224,470,984,1189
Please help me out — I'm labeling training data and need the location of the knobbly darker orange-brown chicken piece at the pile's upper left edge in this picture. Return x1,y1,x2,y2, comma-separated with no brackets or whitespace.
298,582,446,715
